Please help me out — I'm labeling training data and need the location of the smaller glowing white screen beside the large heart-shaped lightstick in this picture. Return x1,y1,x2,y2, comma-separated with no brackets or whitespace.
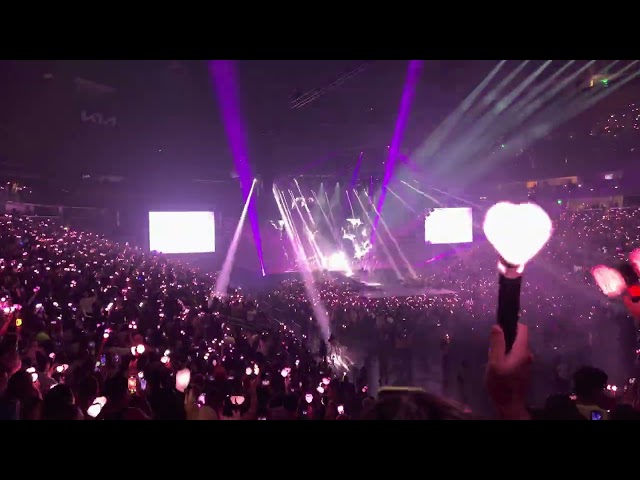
424,208,473,244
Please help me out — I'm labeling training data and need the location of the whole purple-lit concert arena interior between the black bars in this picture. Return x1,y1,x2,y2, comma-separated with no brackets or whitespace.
0,60,640,420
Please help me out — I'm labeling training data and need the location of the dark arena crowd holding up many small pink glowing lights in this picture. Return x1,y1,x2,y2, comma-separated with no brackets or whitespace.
0,209,640,420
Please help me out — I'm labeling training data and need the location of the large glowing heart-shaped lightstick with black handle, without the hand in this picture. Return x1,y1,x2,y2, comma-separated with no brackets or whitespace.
484,202,552,352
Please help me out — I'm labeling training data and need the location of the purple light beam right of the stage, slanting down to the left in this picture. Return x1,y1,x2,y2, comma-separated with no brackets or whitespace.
371,60,424,242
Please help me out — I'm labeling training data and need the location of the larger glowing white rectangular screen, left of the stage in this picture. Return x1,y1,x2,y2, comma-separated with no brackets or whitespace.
149,212,216,253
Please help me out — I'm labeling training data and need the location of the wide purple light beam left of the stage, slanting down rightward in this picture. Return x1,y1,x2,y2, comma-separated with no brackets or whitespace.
209,60,265,275
